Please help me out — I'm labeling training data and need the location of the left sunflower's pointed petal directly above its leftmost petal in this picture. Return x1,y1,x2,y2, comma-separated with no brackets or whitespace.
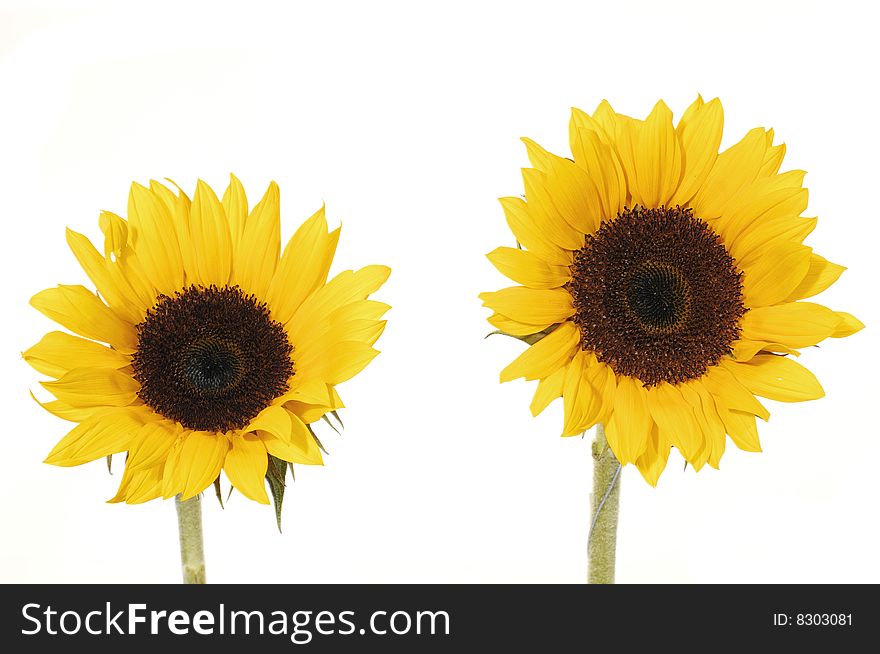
31,285,137,354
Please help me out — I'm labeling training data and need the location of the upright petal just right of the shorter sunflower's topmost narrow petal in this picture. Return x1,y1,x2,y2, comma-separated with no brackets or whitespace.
230,182,281,298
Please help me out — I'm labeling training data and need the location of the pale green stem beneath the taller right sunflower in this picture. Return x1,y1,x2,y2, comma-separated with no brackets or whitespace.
587,424,620,584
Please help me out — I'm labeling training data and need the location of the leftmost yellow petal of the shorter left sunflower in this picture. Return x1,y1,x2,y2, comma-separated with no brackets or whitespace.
22,332,131,378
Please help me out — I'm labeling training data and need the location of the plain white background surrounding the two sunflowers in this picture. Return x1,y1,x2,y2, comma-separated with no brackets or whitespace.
0,0,880,583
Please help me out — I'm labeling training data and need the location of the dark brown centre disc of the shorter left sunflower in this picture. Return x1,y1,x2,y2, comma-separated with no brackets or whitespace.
132,286,293,431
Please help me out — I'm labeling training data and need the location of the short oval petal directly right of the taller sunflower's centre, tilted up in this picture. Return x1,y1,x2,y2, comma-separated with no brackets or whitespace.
743,243,812,307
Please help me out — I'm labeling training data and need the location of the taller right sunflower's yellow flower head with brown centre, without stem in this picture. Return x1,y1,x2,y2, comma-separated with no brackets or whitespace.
480,98,863,485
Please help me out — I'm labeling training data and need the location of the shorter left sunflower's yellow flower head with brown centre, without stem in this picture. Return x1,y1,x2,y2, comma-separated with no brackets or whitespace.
24,176,390,504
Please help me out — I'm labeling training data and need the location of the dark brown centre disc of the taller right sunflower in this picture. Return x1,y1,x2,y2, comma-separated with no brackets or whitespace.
568,206,746,386
